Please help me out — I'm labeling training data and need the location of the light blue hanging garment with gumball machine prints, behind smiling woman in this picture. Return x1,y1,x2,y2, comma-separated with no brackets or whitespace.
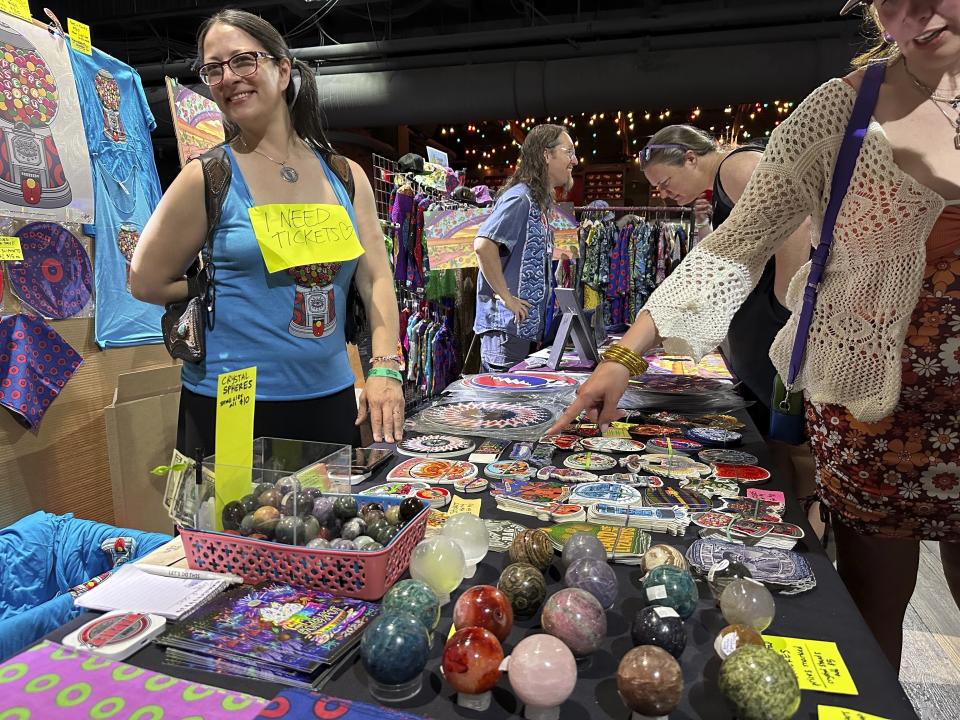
70,40,163,347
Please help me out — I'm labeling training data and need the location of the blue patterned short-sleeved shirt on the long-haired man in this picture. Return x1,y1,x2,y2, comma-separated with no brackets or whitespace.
473,183,553,340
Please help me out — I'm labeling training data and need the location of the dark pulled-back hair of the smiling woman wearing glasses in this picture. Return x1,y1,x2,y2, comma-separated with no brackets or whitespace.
197,10,334,156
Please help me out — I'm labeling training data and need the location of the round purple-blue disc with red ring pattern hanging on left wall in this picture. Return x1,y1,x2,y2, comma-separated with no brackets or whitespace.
7,222,93,320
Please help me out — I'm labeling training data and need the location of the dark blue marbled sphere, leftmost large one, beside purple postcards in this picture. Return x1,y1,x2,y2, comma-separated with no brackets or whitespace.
360,612,430,685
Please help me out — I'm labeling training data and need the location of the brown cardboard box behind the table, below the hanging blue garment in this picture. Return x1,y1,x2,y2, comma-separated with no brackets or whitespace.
104,365,180,533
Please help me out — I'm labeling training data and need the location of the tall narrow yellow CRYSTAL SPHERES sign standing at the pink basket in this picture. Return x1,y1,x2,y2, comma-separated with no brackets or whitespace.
214,367,257,530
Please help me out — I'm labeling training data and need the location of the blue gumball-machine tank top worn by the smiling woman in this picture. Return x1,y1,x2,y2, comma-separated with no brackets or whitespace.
182,148,357,400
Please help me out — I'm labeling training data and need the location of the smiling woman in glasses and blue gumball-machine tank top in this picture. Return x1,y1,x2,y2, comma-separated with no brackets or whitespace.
130,10,404,455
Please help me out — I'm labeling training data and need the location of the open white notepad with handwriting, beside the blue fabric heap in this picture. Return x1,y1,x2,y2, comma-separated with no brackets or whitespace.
74,564,230,620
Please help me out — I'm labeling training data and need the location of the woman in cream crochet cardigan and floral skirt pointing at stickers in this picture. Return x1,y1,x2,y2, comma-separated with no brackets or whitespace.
551,0,960,667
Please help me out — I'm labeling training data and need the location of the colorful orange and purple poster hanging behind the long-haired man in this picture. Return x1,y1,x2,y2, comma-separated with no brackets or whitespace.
423,203,579,270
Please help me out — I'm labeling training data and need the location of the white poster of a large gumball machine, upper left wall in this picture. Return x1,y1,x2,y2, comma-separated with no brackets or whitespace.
0,15,94,222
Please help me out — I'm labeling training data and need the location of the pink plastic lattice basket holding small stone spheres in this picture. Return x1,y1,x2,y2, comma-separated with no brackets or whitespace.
180,495,430,600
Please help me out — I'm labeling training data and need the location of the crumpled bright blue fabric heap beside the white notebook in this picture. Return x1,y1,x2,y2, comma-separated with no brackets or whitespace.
0,511,170,662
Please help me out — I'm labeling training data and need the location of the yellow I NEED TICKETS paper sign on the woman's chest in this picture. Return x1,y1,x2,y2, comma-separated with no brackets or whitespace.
249,203,363,272
